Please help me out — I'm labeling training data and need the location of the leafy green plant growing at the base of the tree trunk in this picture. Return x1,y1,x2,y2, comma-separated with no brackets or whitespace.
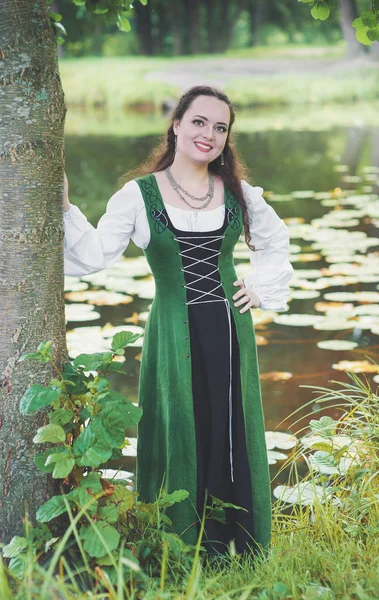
3,331,202,582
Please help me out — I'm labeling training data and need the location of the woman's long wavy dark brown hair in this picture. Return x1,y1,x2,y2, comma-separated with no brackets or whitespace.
118,85,255,250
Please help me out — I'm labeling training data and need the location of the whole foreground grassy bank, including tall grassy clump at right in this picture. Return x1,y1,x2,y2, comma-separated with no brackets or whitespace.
0,375,379,600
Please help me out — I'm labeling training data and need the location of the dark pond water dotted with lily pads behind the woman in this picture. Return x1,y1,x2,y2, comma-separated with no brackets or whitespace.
65,120,379,482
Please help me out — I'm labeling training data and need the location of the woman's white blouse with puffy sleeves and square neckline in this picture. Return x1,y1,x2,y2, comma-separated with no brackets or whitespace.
63,179,293,311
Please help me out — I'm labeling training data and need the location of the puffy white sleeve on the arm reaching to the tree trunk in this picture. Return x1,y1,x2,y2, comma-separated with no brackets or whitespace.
63,180,144,275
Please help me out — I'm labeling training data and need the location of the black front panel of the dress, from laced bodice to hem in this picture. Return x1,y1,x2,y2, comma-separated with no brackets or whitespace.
167,215,254,555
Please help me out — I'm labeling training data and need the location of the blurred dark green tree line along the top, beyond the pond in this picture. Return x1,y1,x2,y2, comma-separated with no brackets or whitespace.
53,0,378,58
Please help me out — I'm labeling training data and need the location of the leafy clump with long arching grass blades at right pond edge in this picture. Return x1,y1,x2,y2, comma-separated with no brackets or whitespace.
274,373,379,538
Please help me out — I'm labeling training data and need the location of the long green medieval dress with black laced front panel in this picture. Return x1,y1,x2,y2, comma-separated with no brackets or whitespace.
136,174,271,553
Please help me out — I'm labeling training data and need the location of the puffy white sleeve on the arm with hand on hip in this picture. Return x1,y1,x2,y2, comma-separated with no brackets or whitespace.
241,180,293,311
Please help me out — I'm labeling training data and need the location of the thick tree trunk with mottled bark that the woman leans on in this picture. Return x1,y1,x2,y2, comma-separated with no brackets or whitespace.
0,0,67,542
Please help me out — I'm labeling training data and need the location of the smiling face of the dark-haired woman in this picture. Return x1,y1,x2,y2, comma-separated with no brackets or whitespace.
174,96,230,163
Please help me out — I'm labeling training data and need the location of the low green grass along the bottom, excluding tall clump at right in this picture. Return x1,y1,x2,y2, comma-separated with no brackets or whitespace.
0,505,379,600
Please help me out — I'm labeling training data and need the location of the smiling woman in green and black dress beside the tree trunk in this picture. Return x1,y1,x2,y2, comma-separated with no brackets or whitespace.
65,86,292,554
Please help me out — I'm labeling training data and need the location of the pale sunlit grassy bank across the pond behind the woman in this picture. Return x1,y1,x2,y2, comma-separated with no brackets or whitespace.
60,49,379,113
